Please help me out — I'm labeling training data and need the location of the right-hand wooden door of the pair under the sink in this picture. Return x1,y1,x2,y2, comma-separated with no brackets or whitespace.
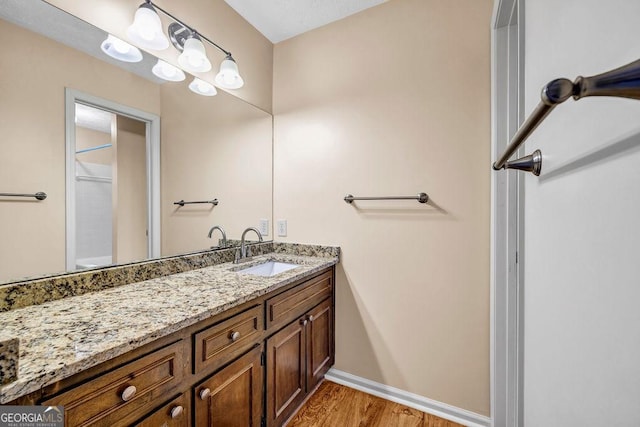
306,299,333,391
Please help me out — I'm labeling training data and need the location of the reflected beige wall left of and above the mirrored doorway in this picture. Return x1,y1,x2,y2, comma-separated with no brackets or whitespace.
0,21,160,281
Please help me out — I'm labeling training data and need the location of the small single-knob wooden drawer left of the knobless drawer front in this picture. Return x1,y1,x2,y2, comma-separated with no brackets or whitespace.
194,305,264,374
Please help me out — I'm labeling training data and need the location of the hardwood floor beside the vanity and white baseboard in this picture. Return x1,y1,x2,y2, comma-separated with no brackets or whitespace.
287,381,462,427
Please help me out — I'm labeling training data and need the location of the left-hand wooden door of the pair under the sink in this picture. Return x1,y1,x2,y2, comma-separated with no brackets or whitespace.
267,319,306,426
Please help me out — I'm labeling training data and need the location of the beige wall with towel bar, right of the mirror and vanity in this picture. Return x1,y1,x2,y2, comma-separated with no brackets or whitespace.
274,0,492,415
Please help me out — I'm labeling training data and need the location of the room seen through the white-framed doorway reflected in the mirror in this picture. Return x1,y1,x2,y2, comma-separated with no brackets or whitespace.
74,103,149,269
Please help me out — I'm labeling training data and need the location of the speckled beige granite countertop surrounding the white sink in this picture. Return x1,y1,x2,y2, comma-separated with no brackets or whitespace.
0,252,338,403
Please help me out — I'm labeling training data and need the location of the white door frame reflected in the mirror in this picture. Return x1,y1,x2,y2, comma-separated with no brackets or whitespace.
64,88,160,271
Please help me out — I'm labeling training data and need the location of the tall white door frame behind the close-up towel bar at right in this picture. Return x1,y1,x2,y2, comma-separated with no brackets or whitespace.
487,0,525,427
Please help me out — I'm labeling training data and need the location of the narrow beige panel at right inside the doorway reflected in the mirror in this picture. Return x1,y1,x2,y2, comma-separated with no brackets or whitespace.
112,116,148,264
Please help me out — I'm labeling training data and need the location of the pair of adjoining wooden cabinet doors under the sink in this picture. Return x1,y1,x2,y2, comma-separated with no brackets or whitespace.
266,298,334,426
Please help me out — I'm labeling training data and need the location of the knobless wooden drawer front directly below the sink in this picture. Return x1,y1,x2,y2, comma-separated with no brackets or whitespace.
267,271,333,329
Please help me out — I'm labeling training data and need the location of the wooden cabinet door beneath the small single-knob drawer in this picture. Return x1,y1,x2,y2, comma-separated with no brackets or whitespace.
194,347,263,427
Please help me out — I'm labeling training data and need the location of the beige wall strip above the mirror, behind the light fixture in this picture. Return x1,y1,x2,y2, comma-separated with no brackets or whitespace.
49,0,273,112
